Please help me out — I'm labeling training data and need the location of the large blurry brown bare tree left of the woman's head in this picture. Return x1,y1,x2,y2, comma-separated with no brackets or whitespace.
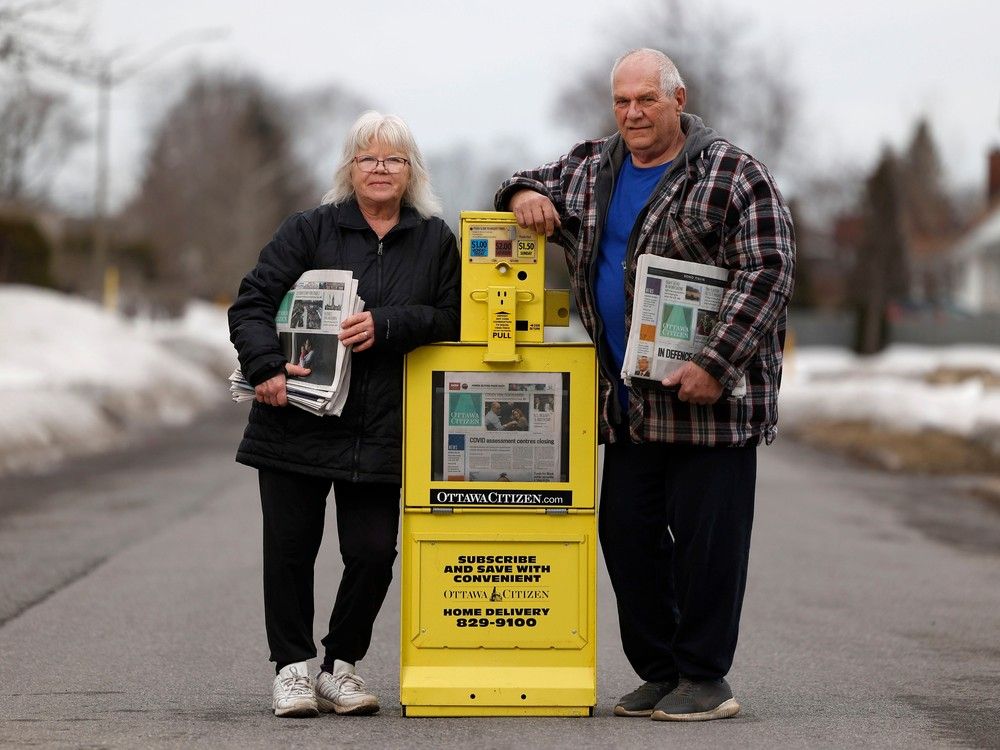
127,73,315,307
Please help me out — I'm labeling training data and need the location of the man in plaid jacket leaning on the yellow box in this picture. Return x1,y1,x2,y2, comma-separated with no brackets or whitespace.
496,49,795,721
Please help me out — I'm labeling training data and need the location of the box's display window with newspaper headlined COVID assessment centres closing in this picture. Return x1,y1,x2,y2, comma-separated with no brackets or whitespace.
432,372,569,482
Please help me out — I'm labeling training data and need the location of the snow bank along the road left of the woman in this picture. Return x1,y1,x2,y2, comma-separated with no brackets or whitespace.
0,286,235,473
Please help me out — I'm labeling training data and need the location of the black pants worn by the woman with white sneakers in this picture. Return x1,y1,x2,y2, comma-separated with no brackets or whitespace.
259,469,399,669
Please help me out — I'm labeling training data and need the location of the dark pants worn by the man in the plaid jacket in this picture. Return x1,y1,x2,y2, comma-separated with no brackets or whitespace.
598,438,757,681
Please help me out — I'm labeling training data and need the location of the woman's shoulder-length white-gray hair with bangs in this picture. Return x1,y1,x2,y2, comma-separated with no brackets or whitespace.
321,110,441,219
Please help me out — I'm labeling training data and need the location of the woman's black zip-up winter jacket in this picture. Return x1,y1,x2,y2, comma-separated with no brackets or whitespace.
229,201,460,484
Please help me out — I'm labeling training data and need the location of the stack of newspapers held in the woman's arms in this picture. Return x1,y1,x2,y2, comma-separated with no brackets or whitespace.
229,269,365,417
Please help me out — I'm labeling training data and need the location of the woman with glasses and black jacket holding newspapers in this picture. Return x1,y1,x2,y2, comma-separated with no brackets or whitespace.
229,112,459,716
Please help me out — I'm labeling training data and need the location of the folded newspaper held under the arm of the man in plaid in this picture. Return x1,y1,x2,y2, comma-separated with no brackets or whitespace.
621,254,746,398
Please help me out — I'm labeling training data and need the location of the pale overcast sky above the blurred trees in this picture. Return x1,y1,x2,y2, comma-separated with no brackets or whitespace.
61,0,1000,212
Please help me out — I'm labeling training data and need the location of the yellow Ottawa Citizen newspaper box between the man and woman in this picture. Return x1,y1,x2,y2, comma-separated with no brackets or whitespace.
400,213,597,716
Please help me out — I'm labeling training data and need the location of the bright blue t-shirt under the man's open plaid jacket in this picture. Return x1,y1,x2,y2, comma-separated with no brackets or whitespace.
594,154,671,414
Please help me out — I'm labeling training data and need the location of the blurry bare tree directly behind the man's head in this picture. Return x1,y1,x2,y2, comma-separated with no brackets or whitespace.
555,0,796,166
